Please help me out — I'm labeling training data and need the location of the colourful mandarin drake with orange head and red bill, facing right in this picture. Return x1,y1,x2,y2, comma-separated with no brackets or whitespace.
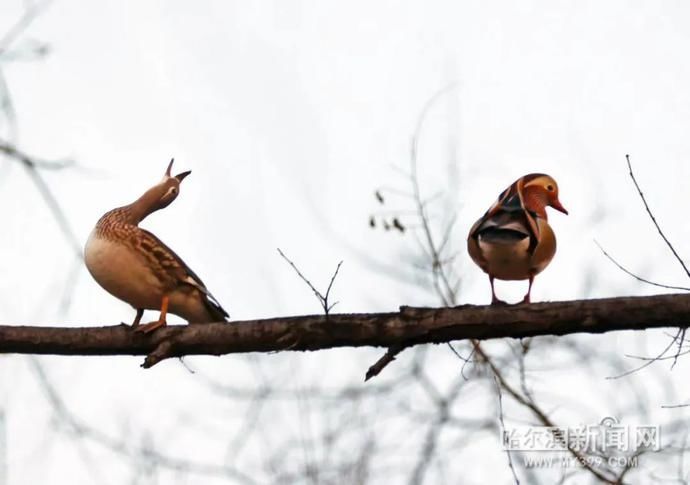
467,173,568,305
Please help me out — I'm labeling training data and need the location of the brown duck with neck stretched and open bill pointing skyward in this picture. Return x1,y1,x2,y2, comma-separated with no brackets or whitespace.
84,160,228,333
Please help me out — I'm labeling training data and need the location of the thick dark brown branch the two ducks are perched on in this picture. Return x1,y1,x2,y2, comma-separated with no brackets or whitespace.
0,294,690,368
